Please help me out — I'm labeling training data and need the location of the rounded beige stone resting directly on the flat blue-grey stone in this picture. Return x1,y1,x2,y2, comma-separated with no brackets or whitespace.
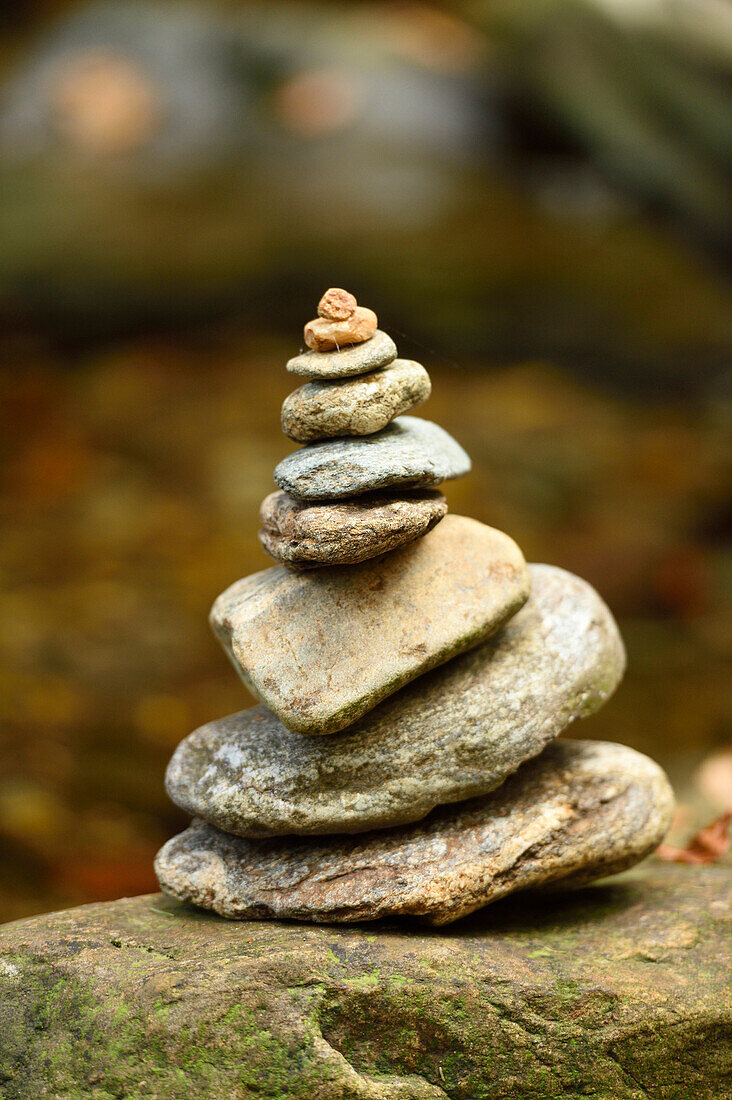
282,359,431,443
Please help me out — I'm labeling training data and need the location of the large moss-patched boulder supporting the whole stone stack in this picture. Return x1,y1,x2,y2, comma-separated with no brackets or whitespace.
0,859,732,1100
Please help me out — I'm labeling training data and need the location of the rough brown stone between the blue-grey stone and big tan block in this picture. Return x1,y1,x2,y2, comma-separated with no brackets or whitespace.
260,490,447,569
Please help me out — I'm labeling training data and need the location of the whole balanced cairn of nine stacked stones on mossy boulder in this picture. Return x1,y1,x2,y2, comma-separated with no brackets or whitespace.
156,289,674,924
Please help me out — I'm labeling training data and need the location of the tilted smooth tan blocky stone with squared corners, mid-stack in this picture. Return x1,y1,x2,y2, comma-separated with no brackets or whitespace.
211,516,529,734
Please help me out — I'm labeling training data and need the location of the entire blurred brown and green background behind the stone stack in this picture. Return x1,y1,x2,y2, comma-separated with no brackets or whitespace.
0,0,732,920
